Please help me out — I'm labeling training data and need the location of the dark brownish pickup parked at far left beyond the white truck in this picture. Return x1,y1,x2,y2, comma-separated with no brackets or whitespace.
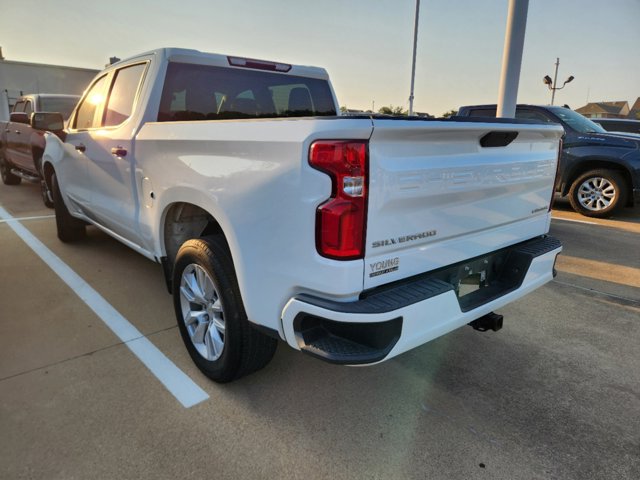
0,93,80,208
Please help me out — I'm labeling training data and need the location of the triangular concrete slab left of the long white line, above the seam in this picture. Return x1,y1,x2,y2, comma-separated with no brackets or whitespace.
0,225,114,378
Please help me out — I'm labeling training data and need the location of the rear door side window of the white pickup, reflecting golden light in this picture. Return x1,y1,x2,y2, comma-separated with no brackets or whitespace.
104,63,147,127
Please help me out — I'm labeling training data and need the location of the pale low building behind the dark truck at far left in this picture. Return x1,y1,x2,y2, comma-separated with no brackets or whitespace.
0,49,99,107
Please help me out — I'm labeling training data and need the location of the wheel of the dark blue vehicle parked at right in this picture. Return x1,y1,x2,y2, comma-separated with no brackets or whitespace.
569,169,629,218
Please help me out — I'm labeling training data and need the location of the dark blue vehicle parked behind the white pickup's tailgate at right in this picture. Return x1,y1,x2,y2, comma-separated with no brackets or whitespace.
458,105,640,218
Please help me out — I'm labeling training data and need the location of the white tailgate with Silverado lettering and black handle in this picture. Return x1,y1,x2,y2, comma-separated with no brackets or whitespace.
364,119,563,289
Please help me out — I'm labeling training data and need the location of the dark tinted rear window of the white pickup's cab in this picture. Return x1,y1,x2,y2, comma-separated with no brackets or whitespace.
158,62,336,122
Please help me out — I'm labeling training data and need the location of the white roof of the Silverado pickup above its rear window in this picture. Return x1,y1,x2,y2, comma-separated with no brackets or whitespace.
105,47,329,80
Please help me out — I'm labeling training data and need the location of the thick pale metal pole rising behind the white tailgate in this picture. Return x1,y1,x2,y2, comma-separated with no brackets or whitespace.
496,0,529,118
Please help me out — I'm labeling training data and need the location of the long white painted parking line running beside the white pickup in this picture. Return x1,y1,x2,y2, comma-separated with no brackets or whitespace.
0,207,209,408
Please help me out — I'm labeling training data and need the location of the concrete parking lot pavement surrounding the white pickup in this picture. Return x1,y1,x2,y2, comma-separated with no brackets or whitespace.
0,181,640,479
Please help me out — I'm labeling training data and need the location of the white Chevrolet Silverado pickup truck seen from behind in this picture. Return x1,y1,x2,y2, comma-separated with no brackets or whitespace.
37,48,563,382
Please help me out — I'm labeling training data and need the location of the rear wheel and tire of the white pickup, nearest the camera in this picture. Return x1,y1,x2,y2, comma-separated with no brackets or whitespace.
173,235,277,383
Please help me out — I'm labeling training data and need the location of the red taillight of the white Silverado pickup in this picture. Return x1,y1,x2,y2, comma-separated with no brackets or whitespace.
309,140,369,260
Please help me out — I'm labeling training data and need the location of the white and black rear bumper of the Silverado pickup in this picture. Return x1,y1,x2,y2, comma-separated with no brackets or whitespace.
282,236,562,365
